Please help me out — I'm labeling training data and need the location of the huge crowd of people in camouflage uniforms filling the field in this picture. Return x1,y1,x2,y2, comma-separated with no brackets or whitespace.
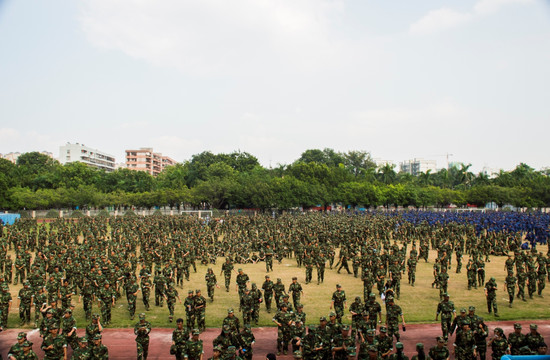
0,212,550,360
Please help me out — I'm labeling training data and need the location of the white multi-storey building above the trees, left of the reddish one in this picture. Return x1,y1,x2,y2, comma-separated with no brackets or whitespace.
59,143,115,172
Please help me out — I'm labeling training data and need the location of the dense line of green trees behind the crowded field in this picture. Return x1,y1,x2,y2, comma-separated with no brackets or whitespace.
0,149,550,210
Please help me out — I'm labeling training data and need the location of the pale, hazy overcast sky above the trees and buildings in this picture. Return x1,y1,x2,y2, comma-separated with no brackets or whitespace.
0,0,550,171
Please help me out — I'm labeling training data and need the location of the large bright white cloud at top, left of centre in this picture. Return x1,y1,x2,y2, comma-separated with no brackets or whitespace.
80,0,343,75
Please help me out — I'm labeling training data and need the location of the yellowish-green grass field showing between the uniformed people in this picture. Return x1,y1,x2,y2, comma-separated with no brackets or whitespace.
8,247,550,328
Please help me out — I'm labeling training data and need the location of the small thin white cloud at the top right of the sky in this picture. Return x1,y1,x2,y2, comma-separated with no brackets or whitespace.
409,0,533,35
